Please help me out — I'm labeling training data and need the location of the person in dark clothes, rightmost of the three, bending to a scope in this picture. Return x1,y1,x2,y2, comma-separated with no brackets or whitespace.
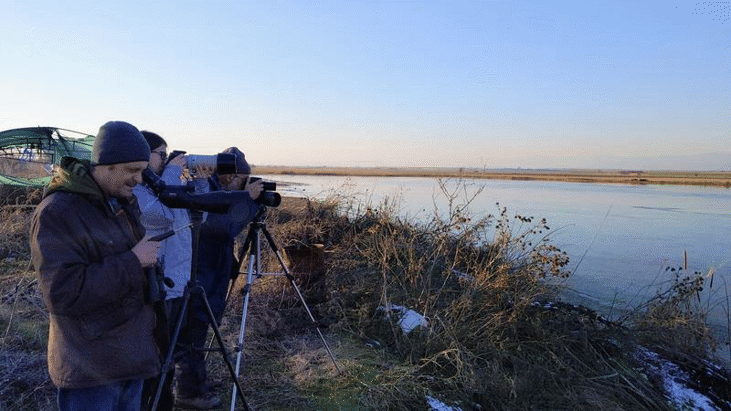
177,147,262,402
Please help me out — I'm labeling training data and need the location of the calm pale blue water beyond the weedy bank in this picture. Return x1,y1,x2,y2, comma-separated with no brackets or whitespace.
265,175,731,327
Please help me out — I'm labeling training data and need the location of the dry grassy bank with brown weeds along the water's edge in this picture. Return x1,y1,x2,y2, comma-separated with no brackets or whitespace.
0,185,731,410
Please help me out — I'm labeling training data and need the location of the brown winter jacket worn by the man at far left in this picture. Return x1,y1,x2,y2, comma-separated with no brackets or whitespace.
30,158,160,388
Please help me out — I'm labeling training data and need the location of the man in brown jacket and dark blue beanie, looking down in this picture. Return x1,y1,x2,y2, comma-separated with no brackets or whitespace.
31,121,160,411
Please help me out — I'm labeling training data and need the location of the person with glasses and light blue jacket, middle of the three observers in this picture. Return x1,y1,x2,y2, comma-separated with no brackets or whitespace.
134,130,221,410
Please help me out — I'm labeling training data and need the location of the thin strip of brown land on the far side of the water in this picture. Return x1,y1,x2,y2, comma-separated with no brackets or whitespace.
252,166,731,188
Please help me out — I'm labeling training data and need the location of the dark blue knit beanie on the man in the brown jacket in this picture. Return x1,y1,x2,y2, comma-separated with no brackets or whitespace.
91,121,150,164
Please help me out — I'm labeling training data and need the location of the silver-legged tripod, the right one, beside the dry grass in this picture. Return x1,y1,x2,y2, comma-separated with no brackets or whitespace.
231,206,340,411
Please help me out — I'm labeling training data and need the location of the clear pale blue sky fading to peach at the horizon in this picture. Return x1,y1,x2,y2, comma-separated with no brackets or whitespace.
0,0,731,171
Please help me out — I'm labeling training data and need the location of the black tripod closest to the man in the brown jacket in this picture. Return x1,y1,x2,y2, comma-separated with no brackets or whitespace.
151,209,249,411
